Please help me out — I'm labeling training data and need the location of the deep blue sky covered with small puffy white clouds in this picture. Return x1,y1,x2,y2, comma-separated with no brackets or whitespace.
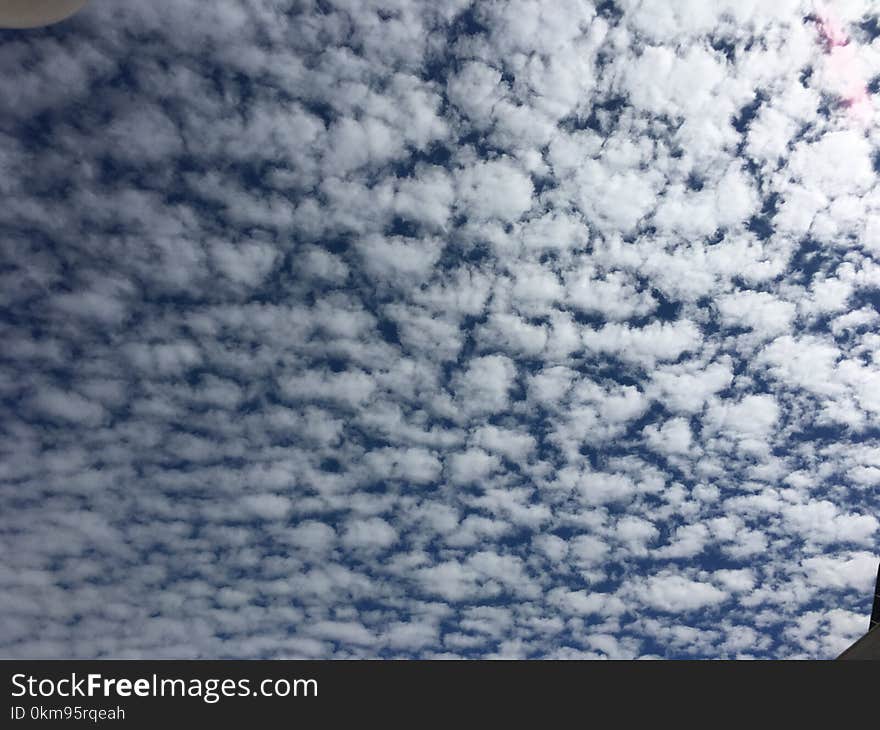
0,0,880,659
